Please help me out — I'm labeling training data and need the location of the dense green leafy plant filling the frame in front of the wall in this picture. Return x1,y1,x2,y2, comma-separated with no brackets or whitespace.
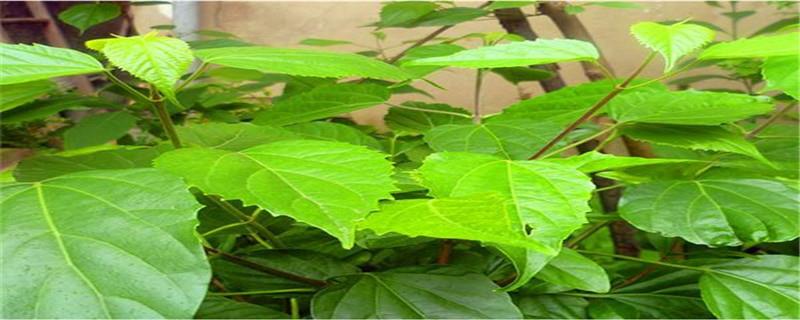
0,1,800,318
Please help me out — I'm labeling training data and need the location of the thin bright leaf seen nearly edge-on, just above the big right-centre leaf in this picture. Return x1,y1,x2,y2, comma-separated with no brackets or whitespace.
542,151,693,173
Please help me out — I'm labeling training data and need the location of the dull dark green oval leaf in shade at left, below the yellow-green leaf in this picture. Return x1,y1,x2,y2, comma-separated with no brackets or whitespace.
64,111,137,150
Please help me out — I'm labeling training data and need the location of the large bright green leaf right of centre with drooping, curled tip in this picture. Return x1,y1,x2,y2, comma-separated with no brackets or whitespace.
420,152,594,289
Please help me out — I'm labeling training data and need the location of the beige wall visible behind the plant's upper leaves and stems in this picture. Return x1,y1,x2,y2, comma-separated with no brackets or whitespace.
139,1,780,128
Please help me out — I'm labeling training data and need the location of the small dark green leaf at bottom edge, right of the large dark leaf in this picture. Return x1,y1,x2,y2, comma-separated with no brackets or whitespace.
517,294,589,319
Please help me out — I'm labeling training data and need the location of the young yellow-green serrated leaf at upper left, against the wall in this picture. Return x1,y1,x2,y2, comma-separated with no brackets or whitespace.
86,32,194,102
